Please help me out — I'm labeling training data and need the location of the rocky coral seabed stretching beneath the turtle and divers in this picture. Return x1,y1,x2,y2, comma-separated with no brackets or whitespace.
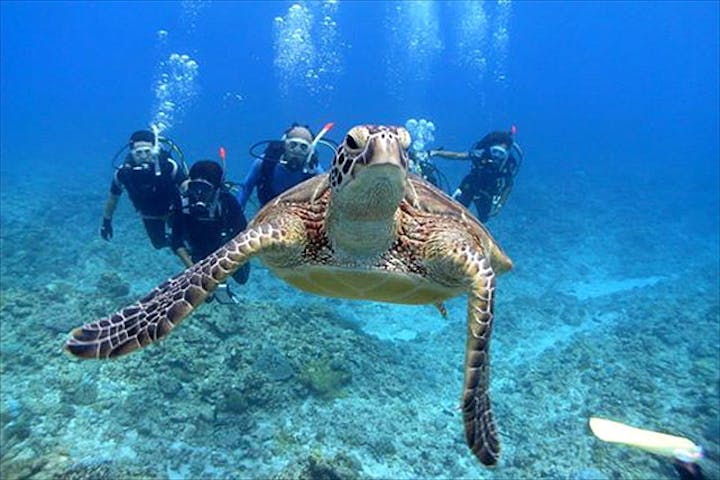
0,164,720,479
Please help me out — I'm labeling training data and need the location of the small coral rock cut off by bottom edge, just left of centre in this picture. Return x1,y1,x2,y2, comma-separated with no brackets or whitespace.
272,452,361,480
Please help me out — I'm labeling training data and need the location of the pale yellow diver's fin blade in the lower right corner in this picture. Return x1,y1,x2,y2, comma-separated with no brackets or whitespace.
590,417,702,462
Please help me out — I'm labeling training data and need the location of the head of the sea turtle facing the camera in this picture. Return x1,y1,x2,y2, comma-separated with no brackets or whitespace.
330,125,410,220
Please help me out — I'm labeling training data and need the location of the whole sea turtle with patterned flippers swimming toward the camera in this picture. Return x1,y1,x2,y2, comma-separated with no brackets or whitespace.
66,125,512,465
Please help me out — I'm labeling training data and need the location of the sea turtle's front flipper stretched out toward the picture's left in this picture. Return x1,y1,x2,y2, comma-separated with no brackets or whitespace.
65,216,304,359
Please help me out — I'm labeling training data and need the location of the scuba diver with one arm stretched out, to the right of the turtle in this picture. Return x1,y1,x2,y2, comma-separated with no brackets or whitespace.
428,125,523,222
